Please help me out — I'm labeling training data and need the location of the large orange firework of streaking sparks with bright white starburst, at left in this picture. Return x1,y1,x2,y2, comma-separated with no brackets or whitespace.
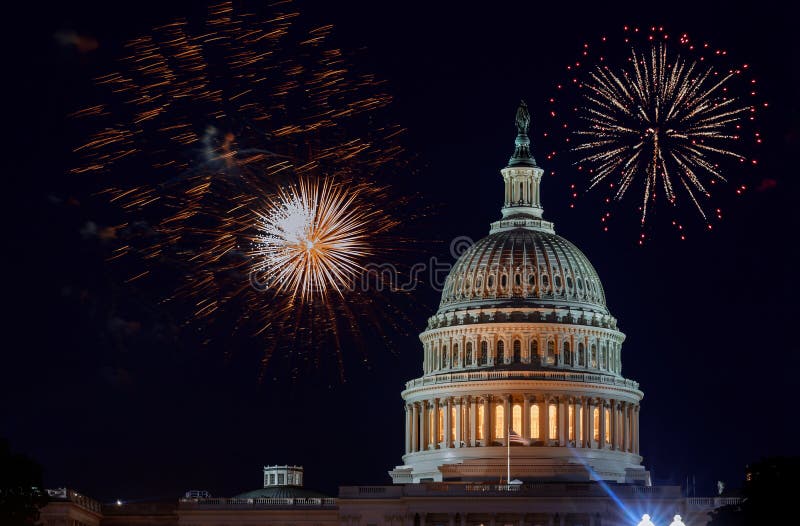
72,2,416,380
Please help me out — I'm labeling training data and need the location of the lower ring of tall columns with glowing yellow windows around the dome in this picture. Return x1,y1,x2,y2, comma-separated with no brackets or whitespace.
405,394,639,454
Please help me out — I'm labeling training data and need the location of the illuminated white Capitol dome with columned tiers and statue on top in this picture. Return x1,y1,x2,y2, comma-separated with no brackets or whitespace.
389,102,649,484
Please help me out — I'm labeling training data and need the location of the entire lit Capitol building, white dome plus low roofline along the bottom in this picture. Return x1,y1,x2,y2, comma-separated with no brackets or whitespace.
41,103,738,526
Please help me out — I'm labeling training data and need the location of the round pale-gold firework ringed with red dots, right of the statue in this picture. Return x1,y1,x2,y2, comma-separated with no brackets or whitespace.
550,27,761,236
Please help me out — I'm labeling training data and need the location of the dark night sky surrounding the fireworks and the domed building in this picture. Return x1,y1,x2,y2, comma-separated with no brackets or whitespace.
0,0,800,500
